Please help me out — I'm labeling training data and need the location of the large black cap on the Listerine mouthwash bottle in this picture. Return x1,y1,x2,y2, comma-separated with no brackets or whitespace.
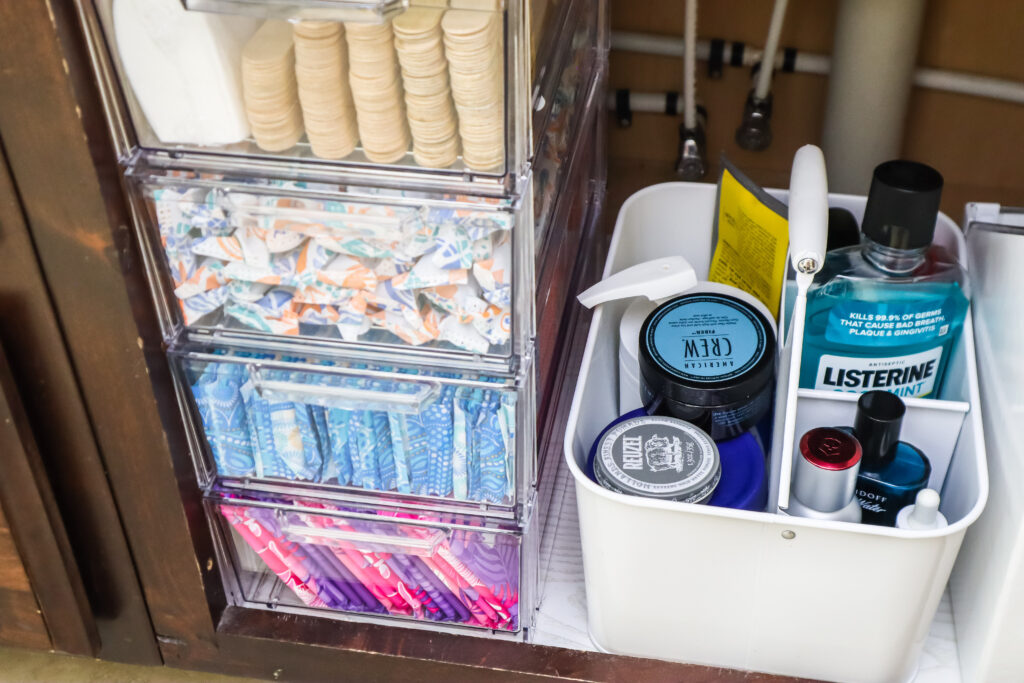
861,160,942,249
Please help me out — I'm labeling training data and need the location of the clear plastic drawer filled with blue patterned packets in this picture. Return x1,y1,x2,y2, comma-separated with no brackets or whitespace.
169,347,536,519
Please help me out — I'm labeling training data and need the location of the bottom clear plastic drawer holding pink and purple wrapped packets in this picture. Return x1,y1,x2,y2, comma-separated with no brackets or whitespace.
206,497,537,639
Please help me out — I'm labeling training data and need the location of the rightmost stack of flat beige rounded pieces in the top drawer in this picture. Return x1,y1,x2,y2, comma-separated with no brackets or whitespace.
441,9,505,171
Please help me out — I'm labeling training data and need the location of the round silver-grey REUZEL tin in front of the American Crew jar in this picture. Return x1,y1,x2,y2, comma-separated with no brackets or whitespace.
594,416,722,503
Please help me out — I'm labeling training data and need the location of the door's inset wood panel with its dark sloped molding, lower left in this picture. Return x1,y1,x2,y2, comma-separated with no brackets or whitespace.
0,348,98,655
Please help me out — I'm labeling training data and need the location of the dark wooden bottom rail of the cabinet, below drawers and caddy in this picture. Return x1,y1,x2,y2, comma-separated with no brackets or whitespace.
195,608,797,683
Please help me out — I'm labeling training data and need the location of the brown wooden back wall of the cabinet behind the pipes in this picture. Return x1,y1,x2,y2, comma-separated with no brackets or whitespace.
610,0,1024,220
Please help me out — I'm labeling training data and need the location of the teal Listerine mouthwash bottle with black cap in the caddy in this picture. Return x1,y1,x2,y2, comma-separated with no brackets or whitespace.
800,161,970,397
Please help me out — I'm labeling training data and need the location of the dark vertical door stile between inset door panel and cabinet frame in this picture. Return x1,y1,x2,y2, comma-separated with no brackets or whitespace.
0,126,159,664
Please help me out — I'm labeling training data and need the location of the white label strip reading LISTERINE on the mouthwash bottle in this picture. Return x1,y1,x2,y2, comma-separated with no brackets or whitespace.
814,346,942,397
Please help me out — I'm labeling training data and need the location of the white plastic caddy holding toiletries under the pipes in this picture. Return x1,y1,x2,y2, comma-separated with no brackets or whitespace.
565,182,988,682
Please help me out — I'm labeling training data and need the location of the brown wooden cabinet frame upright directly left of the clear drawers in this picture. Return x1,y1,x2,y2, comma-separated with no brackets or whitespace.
0,0,204,663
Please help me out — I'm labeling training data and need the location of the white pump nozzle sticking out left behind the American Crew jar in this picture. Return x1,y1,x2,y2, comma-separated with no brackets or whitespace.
577,256,697,308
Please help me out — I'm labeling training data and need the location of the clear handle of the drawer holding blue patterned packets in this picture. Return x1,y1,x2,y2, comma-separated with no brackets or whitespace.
249,366,440,415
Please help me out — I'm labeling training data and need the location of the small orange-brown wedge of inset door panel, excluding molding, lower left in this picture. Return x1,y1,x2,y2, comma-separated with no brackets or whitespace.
0,509,50,649
